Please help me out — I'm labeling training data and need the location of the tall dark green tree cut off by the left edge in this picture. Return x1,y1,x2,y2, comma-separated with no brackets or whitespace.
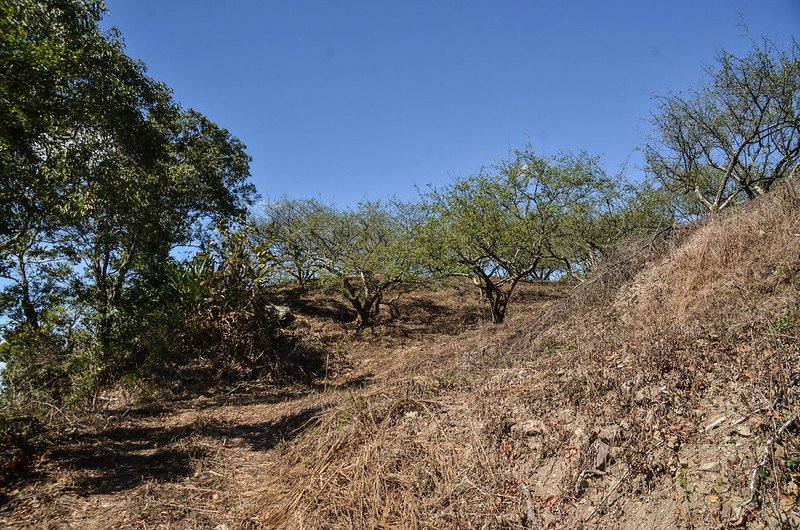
0,0,169,328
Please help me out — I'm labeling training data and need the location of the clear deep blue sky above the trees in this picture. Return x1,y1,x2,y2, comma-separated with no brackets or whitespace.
105,0,800,205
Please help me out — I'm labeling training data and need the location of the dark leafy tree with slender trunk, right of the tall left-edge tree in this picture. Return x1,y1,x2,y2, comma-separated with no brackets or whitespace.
60,108,250,370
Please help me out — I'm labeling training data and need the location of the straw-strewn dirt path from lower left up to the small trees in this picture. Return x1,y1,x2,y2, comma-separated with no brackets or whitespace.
0,282,564,530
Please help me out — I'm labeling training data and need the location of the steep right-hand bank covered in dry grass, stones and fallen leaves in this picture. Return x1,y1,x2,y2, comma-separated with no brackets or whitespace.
250,179,800,528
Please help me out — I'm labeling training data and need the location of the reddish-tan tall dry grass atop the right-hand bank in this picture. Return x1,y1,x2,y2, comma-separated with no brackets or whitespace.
629,183,800,323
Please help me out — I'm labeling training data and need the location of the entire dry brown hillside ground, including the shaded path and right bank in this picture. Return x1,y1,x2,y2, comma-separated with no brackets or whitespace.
0,179,800,529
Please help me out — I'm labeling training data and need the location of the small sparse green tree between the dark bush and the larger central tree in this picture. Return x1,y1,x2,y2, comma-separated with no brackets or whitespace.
254,198,420,327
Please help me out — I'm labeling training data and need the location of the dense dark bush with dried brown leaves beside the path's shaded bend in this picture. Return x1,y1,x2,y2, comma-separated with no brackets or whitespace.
126,224,320,384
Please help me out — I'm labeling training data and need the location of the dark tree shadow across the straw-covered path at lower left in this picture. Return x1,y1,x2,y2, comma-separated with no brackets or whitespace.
50,408,320,495
